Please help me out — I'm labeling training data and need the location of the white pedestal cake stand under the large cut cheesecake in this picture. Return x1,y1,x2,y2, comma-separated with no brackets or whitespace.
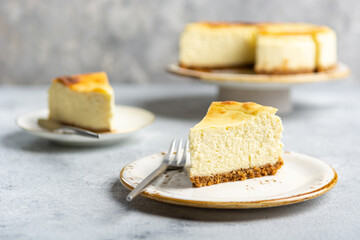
167,63,350,114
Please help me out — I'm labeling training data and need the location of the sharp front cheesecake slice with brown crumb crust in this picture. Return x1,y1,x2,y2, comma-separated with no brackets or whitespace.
189,101,283,187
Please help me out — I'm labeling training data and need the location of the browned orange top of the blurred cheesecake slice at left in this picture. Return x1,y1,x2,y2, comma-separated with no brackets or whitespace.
53,72,112,93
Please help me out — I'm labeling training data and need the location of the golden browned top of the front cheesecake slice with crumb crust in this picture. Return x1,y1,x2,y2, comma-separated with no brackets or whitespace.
194,101,277,128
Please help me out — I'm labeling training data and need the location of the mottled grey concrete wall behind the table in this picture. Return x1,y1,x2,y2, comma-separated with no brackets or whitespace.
0,0,360,84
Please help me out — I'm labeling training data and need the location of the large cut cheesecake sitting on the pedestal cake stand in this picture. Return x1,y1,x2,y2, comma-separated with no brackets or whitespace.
179,22,337,74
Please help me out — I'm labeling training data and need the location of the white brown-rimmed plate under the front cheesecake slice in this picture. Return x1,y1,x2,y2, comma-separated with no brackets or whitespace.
120,152,337,208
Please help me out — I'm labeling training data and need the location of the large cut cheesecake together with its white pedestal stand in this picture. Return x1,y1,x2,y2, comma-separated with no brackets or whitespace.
168,22,349,113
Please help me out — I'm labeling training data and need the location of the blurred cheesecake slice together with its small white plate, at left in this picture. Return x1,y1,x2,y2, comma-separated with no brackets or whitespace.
16,72,155,145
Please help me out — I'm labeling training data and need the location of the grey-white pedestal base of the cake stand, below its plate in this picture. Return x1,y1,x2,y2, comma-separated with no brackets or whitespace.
218,86,292,114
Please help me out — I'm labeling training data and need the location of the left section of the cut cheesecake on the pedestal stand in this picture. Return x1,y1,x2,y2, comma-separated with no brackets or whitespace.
179,22,257,69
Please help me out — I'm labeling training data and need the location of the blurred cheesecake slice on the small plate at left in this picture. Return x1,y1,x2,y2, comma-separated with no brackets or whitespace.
48,72,115,132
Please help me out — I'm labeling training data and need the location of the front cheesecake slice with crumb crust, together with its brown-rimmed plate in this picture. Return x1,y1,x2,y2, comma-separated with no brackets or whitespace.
120,101,337,208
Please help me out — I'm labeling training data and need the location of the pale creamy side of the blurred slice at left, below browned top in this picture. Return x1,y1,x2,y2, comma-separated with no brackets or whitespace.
49,81,114,132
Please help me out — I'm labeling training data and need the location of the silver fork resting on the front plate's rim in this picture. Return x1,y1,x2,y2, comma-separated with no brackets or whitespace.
126,138,189,202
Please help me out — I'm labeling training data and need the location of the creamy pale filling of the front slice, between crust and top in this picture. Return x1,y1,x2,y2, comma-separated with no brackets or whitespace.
189,112,283,177
